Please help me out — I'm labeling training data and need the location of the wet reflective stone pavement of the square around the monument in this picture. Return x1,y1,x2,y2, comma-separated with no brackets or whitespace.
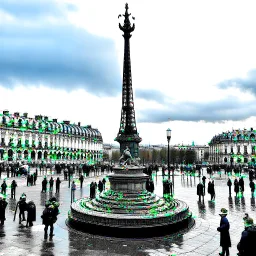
0,171,256,256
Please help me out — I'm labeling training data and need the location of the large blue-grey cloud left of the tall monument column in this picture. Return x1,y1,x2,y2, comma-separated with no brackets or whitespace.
0,0,121,96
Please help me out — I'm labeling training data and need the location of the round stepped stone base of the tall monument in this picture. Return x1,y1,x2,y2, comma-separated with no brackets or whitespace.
69,166,194,237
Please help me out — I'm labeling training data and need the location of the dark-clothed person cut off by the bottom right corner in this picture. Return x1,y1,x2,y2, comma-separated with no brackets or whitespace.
237,218,256,256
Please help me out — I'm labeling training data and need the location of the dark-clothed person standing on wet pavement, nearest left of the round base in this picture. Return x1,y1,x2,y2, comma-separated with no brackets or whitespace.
41,204,57,239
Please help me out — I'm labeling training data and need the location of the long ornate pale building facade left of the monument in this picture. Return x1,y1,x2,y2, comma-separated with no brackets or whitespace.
0,110,103,164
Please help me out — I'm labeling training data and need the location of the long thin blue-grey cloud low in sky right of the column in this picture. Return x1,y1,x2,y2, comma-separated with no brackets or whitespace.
138,98,256,123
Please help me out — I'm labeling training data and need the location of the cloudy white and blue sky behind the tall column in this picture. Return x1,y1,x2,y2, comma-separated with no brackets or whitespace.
0,0,256,144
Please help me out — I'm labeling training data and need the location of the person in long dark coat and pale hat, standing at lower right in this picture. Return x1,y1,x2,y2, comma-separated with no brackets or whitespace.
217,208,231,256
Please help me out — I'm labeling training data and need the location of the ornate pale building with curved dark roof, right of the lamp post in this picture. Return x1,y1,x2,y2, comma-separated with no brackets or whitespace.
209,128,256,165
